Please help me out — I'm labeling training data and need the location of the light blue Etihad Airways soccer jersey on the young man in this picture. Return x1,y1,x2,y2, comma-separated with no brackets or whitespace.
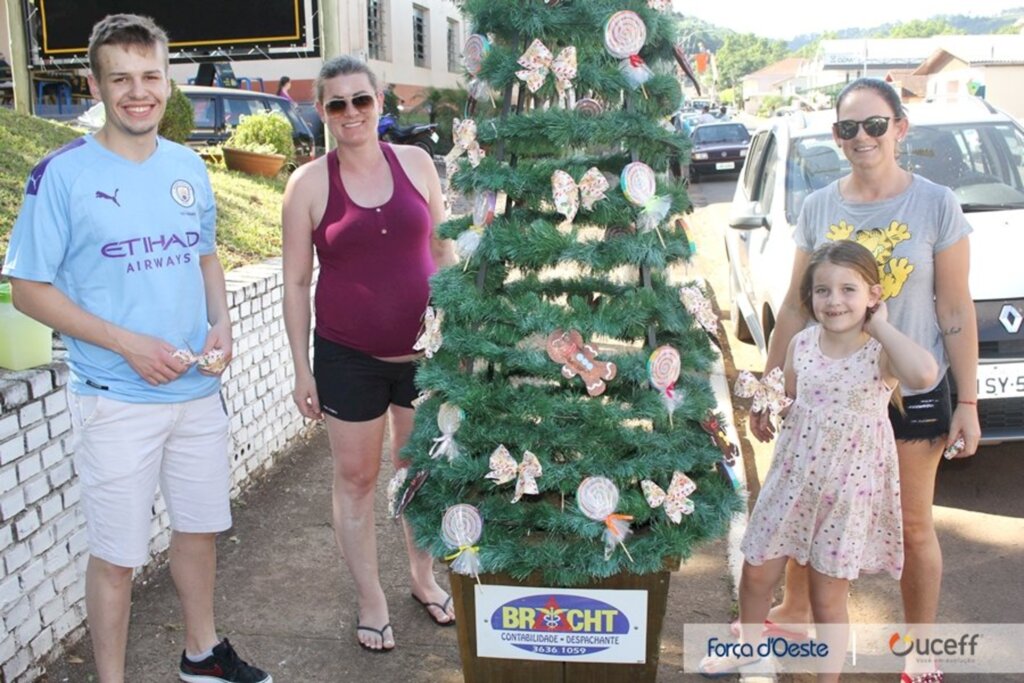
3,135,220,403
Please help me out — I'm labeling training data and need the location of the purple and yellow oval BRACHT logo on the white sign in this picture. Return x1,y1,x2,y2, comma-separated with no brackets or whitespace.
490,593,630,657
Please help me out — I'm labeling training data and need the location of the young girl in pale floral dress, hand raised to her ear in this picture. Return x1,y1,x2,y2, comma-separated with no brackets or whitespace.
700,241,938,681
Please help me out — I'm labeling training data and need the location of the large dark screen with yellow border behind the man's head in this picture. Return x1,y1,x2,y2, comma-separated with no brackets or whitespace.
37,0,305,57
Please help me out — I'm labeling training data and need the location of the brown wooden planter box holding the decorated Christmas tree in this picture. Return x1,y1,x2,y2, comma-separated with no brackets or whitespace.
449,563,678,683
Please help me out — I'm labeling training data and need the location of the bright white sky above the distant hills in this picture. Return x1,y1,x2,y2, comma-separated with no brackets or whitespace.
673,0,1024,40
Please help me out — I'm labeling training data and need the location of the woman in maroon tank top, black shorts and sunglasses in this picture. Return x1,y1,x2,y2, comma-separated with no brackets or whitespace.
282,56,455,651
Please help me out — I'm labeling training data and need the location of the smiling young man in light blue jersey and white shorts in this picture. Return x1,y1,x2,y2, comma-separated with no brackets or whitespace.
3,14,271,683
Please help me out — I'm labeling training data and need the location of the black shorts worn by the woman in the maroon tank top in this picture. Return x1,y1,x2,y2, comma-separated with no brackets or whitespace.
313,334,417,422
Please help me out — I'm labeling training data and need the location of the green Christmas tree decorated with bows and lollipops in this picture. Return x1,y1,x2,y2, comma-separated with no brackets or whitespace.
389,0,741,586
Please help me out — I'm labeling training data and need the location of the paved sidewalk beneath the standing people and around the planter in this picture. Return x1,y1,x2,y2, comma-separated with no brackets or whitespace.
41,423,732,683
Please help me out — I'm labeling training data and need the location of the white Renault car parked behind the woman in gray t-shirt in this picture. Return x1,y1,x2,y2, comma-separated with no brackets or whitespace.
725,99,1024,442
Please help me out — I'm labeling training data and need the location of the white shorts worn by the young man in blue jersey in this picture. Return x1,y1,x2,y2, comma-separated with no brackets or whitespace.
68,390,231,567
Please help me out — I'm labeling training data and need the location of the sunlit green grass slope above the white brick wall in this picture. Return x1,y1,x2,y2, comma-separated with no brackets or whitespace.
0,106,285,270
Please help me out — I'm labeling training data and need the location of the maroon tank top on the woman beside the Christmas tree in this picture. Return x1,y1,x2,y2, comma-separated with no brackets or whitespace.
313,142,435,357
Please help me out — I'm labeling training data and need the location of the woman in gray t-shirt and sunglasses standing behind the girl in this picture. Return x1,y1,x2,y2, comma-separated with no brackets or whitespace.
751,79,981,683
